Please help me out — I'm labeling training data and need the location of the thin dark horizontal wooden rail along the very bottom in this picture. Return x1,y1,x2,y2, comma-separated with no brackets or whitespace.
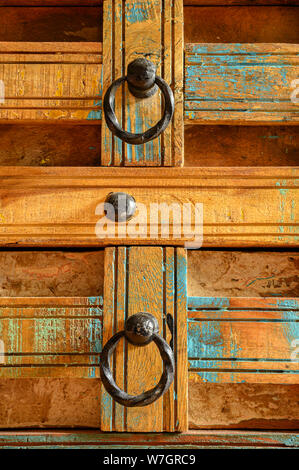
0,431,299,449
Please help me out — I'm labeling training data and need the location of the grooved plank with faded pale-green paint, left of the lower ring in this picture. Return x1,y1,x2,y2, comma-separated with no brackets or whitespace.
0,297,102,378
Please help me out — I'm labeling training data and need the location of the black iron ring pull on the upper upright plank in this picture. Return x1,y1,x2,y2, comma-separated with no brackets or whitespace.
103,58,174,145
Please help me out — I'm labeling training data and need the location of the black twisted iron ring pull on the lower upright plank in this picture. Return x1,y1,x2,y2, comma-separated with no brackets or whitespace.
100,313,174,407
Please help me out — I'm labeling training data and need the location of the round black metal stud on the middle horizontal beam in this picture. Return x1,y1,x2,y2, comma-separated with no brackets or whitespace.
104,192,136,222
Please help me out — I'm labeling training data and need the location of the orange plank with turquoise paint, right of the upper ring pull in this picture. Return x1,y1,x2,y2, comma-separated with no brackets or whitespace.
185,44,299,124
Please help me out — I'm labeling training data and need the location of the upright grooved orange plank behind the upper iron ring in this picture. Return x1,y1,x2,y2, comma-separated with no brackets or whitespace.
102,0,184,166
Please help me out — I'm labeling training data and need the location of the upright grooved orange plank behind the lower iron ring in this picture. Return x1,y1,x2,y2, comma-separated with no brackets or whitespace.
101,247,187,432
